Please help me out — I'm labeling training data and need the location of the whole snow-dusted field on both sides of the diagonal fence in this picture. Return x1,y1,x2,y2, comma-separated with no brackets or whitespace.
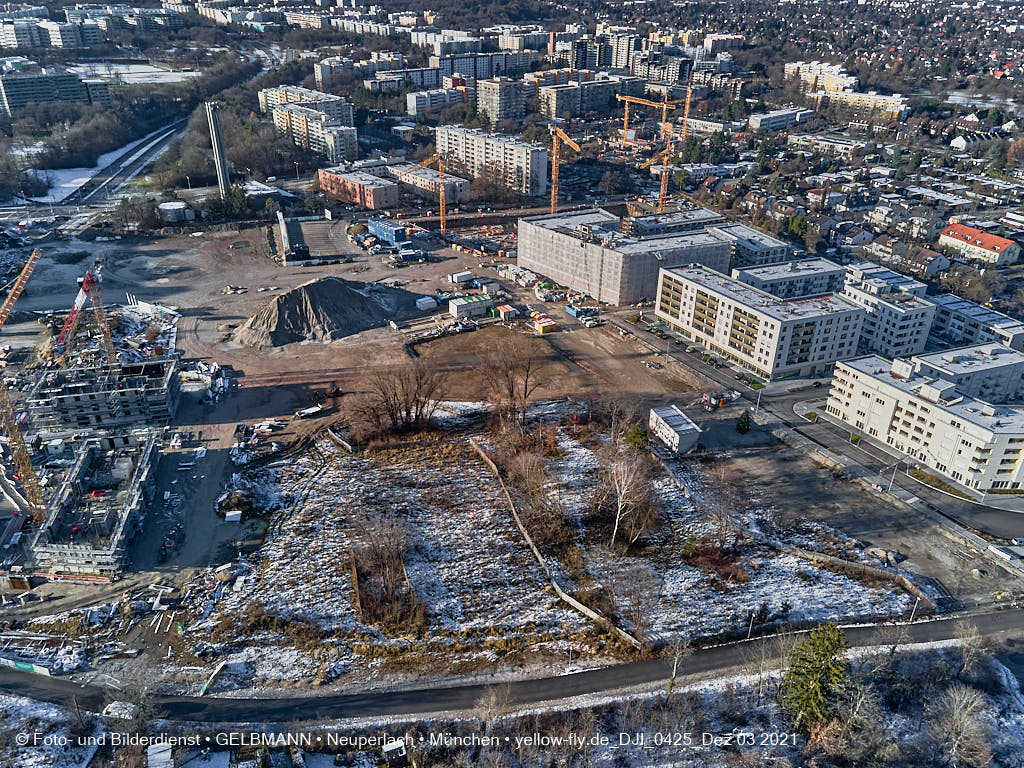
182,415,912,682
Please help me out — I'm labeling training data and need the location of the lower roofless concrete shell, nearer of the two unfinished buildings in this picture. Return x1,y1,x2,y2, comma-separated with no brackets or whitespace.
29,429,159,579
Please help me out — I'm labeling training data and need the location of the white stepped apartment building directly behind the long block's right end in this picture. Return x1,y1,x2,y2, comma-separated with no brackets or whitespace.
843,261,935,357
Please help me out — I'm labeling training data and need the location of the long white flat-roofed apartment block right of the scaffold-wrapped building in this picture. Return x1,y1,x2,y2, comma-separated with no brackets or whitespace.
655,265,864,380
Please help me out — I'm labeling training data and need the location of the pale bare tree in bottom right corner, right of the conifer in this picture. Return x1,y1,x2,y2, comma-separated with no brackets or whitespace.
928,683,992,768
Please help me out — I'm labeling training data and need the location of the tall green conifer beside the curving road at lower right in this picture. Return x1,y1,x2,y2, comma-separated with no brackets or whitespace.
781,623,850,728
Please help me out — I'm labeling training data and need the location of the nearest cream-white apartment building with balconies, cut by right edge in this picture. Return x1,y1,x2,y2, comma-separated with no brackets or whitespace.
825,355,1024,492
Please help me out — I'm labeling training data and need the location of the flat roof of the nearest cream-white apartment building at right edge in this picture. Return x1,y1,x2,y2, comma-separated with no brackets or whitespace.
839,354,1024,434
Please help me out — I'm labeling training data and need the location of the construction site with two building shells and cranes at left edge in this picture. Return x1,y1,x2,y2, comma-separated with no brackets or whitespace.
0,250,181,587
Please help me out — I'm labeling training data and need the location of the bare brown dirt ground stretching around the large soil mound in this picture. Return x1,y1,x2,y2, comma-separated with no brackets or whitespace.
3,229,1011,626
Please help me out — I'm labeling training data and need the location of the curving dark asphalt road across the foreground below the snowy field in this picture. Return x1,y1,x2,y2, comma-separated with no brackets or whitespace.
0,608,1024,723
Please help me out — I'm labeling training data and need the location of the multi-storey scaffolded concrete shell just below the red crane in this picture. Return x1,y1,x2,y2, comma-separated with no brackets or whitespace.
25,356,181,432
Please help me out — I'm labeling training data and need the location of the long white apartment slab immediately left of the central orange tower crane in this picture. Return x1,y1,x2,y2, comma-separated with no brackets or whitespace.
435,125,548,196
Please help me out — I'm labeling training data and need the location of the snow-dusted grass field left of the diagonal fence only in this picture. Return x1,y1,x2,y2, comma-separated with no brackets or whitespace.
200,438,589,677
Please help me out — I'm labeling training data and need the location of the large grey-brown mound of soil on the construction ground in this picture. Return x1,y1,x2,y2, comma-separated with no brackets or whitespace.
231,278,416,347
